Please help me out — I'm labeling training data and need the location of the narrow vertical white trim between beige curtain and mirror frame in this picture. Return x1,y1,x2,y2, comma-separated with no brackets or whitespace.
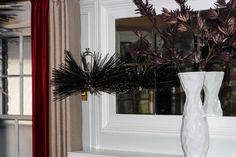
80,0,99,149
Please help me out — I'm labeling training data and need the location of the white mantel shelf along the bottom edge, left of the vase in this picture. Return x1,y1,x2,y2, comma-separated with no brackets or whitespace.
68,150,183,157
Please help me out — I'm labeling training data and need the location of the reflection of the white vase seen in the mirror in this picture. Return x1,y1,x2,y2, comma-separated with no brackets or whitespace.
203,72,224,116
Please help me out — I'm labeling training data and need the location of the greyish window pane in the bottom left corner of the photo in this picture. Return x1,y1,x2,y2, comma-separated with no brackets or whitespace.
0,120,16,157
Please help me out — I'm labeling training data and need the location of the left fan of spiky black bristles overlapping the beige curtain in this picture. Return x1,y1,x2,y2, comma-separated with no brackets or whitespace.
51,51,89,100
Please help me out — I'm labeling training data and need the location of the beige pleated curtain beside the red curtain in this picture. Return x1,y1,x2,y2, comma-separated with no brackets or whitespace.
50,0,82,157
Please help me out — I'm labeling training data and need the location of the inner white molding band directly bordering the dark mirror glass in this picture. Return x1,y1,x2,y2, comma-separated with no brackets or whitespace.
97,0,236,136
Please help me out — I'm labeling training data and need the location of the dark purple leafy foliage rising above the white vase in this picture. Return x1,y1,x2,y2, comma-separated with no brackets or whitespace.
132,0,236,70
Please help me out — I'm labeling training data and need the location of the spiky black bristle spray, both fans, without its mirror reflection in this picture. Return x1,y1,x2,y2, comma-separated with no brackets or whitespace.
51,51,136,100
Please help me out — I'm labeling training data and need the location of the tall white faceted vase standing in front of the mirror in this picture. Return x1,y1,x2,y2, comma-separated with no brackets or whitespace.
178,72,209,157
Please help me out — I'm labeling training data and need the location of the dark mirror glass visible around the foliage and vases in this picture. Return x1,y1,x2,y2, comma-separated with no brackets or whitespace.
116,10,236,116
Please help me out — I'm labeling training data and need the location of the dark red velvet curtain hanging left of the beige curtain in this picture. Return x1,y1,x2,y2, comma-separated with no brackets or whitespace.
31,0,49,157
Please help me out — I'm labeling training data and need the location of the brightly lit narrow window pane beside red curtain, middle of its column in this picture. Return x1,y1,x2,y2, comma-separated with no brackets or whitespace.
24,77,32,115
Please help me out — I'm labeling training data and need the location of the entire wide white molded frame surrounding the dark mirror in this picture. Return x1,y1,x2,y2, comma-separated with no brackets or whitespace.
81,0,236,157
